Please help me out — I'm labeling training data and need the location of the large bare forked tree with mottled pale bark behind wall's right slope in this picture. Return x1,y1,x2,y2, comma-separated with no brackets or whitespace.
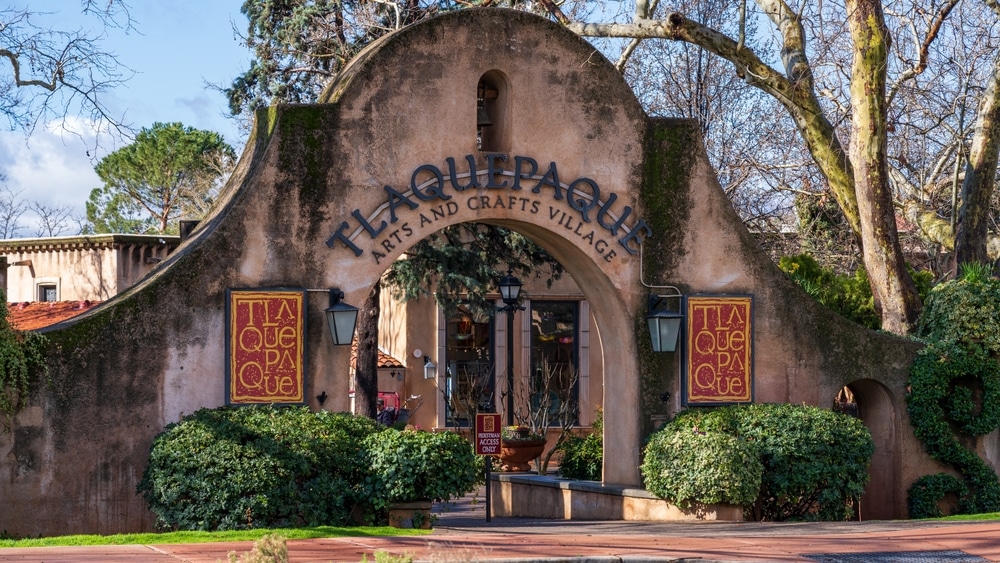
549,0,996,333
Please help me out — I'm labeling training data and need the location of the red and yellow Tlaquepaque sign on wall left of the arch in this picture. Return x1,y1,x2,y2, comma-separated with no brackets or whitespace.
226,290,306,404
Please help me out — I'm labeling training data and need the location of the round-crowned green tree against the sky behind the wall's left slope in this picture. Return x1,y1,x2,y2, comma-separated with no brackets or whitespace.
87,123,236,233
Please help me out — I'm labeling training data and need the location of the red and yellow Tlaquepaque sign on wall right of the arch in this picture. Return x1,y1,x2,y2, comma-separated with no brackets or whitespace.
684,296,753,404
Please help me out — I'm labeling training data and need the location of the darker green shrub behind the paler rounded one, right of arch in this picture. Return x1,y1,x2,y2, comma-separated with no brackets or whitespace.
646,403,875,521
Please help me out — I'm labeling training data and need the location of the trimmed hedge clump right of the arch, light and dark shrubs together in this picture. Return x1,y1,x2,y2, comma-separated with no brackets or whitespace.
643,403,875,521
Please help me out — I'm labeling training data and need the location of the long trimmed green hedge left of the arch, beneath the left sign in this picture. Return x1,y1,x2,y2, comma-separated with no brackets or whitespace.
138,406,483,530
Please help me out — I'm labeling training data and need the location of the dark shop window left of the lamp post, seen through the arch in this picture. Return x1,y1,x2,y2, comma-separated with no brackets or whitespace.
445,306,495,427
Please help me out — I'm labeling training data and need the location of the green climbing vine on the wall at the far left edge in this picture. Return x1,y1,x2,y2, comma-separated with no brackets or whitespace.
0,300,48,434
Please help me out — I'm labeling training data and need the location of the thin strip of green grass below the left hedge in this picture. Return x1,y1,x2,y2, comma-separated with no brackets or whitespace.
0,526,431,548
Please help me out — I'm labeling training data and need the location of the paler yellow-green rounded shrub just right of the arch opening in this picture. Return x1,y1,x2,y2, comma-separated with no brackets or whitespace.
642,427,764,508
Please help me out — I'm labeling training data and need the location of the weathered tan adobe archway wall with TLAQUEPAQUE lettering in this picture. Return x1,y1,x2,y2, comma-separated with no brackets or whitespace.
0,9,968,535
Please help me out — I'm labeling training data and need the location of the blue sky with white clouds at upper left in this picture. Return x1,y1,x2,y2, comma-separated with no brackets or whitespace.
0,0,250,229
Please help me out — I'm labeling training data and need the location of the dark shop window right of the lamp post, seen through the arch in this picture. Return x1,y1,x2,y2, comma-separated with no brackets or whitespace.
530,301,580,425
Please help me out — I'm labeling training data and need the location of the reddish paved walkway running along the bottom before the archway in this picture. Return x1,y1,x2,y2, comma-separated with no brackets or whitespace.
0,492,1000,563
